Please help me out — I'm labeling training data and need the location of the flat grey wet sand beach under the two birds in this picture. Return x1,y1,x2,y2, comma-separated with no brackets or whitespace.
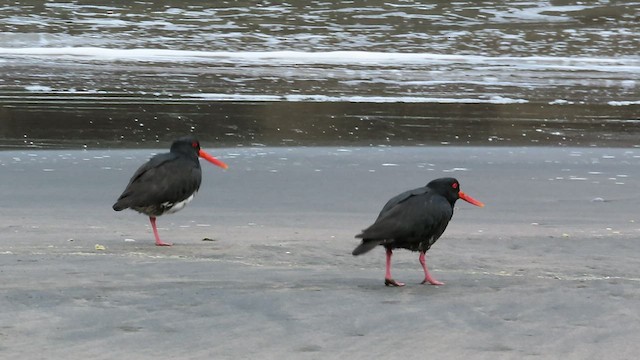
0,146,640,359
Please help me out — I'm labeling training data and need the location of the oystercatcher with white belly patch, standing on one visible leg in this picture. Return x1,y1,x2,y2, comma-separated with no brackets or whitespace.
113,136,227,246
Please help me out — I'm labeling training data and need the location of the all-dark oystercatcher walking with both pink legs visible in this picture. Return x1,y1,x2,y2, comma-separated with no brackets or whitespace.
353,178,484,286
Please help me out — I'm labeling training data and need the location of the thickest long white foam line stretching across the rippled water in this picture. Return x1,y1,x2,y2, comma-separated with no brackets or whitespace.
0,47,640,73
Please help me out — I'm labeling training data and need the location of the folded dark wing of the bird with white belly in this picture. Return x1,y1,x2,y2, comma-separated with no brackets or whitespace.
113,153,202,209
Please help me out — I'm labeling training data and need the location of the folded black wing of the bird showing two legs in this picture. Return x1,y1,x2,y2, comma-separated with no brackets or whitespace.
356,193,453,240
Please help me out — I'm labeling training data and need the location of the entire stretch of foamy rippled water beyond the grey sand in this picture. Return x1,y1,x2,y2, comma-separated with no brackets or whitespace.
0,1,640,147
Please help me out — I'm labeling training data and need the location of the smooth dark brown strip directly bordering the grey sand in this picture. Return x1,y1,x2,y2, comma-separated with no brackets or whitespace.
0,101,640,148
